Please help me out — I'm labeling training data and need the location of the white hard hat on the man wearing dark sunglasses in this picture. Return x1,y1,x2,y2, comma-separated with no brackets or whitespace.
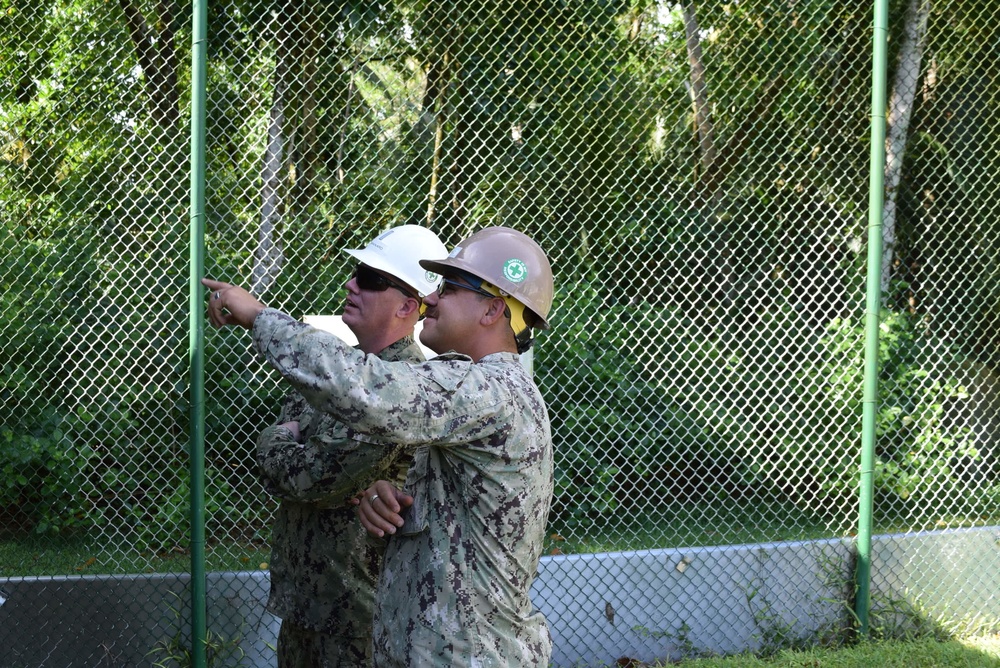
344,225,448,298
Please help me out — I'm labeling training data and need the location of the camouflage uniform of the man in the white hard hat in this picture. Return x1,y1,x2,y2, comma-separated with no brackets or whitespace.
257,337,424,668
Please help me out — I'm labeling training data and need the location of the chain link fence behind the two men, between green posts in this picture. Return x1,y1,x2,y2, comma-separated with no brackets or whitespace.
0,0,1000,666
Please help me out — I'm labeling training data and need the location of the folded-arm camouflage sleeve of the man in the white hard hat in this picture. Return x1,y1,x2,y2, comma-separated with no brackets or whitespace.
257,425,406,506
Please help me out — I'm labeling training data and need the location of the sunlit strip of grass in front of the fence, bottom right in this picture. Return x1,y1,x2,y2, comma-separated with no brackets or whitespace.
660,635,1000,668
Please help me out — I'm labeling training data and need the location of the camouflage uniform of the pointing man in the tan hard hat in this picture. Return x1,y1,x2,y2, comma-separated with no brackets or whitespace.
253,309,552,668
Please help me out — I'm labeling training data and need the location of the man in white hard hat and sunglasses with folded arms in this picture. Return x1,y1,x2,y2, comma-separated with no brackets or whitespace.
257,225,447,668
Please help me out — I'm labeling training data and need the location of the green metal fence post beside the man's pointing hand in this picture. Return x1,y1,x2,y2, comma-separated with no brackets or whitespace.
189,0,208,668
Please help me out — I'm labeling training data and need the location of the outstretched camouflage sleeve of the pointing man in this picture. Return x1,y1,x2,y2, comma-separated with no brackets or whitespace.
253,309,514,445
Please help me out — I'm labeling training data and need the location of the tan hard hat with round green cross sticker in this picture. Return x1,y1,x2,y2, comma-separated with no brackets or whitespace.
420,227,554,329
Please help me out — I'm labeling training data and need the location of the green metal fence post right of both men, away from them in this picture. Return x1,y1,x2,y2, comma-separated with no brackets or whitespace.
855,0,889,635
